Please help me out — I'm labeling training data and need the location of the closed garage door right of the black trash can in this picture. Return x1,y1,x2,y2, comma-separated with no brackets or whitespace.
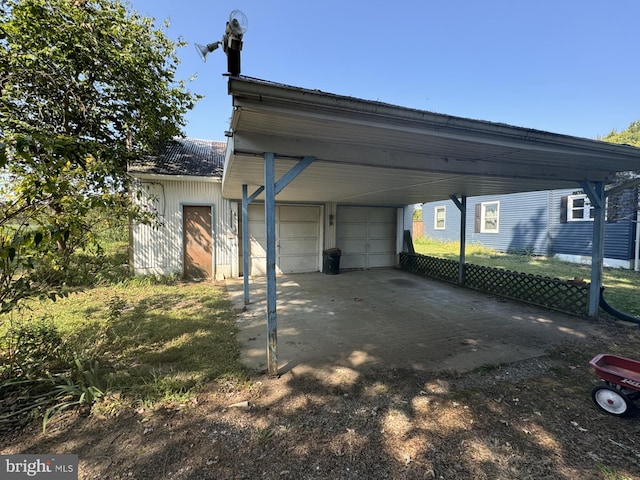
336,206,397,268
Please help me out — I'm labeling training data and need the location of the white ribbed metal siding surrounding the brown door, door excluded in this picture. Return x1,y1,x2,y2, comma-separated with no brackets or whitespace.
133,179,238,279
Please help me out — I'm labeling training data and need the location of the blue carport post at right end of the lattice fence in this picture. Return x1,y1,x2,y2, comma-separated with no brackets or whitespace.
580,181,606,317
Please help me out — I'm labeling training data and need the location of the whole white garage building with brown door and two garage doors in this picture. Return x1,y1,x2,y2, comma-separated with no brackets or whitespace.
129,139,413,279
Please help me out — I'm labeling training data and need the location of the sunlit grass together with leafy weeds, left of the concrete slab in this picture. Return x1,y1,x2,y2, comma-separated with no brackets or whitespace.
0,234,247,428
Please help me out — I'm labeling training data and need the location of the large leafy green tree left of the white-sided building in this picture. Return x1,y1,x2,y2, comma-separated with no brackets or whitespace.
0,0,198,311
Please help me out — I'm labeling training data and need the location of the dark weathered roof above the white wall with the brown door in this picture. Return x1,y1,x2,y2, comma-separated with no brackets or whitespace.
129,138,227,177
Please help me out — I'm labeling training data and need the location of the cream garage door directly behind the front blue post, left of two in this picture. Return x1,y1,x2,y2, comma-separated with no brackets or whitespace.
249,204,321,276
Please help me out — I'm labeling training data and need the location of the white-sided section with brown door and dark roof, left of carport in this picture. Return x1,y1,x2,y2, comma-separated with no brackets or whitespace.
129,139,238,279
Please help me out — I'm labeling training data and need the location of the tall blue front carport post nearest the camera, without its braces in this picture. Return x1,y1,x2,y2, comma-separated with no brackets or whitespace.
264,152,278,376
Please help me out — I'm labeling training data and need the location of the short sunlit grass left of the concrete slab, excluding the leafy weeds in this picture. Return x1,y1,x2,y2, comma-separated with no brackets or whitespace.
0,279,246,412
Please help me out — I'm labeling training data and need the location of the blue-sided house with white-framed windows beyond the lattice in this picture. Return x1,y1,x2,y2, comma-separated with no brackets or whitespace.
422,189,638,268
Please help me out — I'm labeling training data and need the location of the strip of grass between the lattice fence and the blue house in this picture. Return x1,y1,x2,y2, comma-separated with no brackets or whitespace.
414,237,640,317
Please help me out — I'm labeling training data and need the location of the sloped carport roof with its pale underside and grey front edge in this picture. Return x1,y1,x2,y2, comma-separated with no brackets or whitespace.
223,77,640,205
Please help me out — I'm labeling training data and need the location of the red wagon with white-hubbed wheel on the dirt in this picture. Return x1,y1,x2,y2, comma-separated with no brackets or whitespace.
589,353,640,416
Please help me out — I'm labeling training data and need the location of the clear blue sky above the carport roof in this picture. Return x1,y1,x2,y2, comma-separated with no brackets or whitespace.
130,0,640,140
